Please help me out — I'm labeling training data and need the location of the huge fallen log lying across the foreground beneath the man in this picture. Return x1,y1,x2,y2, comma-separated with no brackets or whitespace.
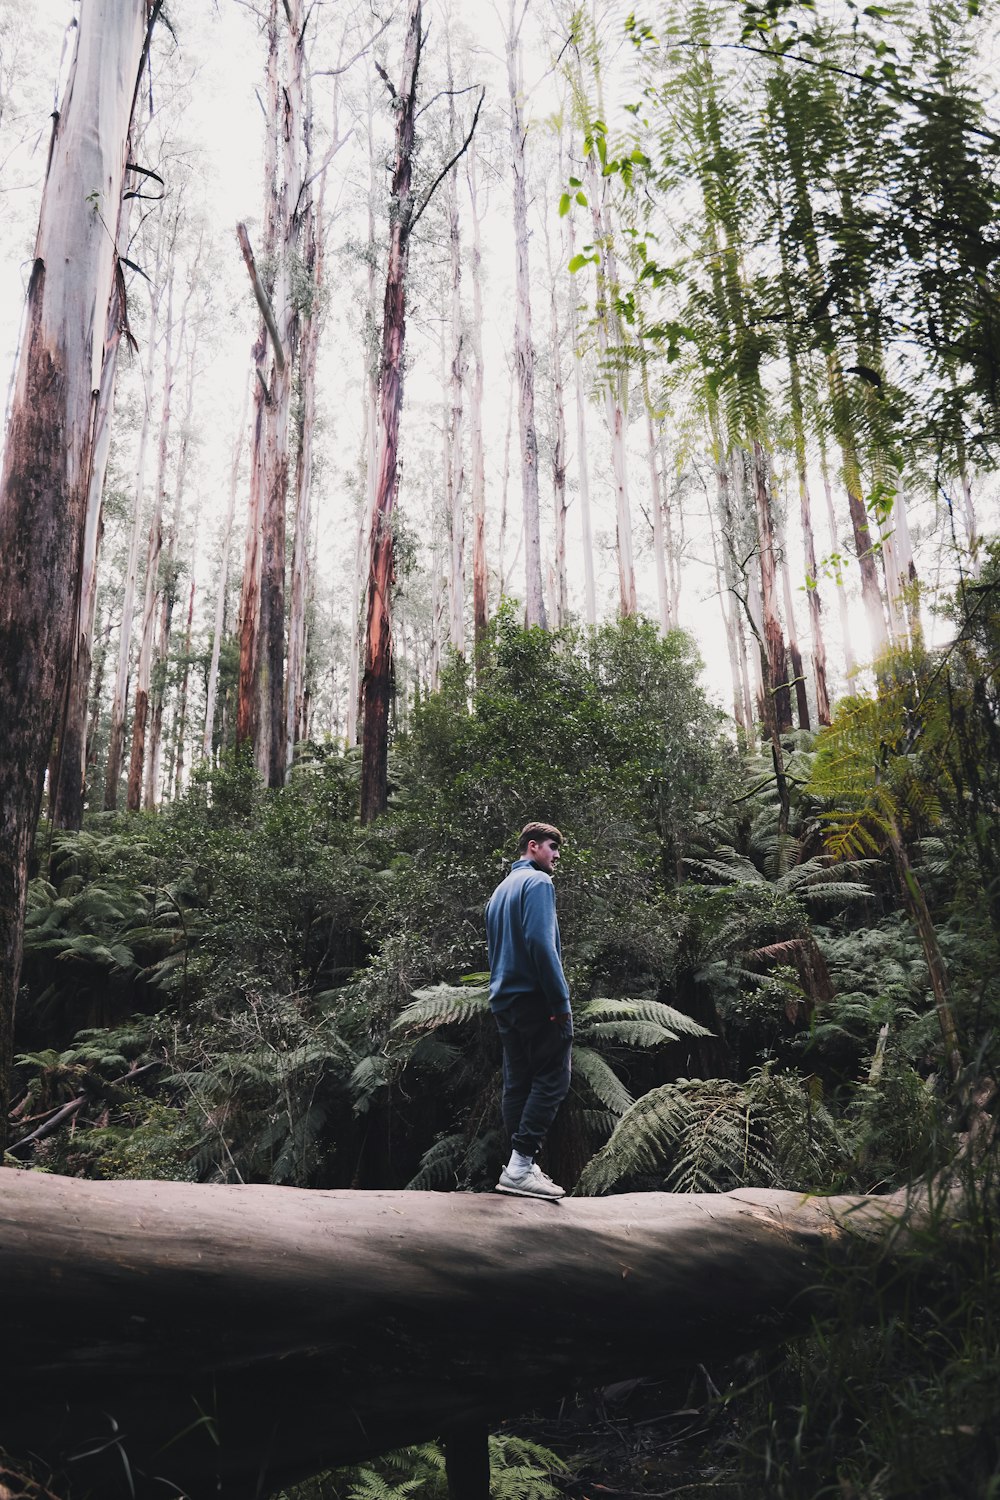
0,1170,958,1500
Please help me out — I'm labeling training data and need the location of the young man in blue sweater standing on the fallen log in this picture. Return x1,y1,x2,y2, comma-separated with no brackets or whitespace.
486,824,573,1200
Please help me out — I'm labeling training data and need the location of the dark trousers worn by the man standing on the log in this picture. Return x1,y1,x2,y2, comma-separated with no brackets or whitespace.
493,995,573,1157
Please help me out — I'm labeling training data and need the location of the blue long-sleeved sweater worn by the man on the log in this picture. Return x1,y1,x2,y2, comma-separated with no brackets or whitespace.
486,860,570,1016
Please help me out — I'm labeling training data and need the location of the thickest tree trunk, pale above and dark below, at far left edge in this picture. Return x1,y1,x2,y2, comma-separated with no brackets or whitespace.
0,0,153,1148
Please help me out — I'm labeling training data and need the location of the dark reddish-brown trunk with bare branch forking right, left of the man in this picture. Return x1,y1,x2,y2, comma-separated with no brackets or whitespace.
361,0,421,824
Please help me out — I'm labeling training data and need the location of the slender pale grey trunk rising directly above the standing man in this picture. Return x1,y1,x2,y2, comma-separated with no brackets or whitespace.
507,0,547,630
